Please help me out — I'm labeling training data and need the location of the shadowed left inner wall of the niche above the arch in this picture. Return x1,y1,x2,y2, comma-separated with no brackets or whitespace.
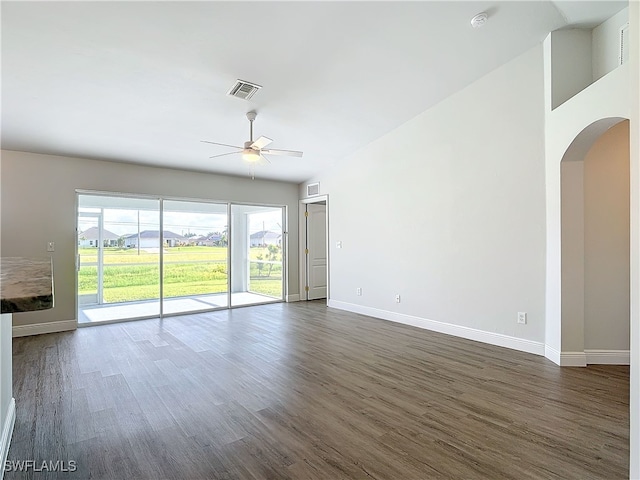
550,28,593,108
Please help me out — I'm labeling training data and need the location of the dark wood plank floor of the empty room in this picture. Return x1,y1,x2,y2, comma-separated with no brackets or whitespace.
5,302,629,480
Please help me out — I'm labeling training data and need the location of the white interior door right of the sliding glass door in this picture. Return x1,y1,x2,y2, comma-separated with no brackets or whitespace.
306,203,327,300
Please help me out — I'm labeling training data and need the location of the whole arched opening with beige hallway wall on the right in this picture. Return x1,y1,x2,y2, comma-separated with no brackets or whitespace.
560,118,630,366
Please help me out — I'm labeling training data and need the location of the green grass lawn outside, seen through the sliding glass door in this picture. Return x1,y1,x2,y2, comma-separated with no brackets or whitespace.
78,247,282,303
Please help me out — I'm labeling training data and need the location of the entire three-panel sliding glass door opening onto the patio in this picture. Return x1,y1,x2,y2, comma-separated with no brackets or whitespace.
77,192,286,324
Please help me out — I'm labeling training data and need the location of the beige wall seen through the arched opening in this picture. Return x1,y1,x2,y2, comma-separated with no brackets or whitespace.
584,122,630,351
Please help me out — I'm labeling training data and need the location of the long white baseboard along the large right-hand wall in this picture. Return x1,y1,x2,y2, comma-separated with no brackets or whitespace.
328,300,545,355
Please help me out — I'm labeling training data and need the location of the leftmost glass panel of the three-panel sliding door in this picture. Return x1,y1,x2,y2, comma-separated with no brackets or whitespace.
77,195,160,323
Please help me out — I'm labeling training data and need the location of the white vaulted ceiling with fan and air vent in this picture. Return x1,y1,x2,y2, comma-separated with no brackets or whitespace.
1,1,627,182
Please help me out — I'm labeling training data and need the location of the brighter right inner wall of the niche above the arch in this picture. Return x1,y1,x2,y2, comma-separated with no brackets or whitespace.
591,7,629,81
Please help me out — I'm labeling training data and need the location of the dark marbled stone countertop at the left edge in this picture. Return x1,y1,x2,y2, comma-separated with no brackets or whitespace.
0,257,53,313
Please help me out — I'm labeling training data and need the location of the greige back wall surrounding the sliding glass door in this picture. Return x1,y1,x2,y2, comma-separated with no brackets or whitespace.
1,151,299,325
